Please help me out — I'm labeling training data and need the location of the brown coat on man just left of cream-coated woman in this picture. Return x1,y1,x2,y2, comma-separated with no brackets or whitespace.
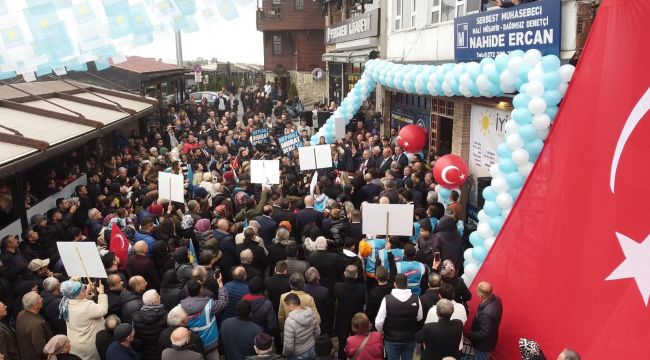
16,310,52,359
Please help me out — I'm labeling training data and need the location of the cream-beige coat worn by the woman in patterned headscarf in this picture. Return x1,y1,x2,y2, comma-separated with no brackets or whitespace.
66,294,108,360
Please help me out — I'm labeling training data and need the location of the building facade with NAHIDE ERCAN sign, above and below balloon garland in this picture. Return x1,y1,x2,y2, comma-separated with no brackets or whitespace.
381,0,597,217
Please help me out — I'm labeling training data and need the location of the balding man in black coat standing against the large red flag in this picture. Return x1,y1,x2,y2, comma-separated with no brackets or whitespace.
467,281,503,359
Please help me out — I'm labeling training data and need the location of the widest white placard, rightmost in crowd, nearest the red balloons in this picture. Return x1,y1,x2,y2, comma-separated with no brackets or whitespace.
361,203,413,236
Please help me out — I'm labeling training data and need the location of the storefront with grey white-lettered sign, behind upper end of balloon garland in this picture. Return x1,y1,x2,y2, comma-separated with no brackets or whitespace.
322,9,379,103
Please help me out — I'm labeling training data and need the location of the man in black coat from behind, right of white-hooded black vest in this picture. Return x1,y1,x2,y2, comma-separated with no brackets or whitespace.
415,299,463,360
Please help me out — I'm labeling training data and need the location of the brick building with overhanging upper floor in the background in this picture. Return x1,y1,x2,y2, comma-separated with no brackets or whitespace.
257,0,327,105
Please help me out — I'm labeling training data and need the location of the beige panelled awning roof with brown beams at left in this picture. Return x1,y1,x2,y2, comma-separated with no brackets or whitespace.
0,81,157,177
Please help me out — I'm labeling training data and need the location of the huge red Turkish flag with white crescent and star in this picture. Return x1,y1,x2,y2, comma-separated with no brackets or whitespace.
472,0,650,359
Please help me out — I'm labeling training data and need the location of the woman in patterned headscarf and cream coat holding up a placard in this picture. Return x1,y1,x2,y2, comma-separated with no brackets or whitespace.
59,280,108,360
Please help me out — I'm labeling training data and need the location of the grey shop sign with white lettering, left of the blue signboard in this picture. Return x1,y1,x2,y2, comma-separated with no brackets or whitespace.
325,9,379,45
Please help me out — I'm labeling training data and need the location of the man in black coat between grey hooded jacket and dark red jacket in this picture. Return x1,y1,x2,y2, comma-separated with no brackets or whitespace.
334,265,366,359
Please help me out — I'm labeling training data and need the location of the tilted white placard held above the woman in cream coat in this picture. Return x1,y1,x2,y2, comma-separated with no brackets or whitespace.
56,241,108,278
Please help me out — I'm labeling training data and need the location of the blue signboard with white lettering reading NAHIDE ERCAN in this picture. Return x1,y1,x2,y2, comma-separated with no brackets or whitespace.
454,0,562,61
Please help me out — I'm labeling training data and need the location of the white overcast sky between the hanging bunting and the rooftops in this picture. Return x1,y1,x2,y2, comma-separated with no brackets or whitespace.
128,1,264,64
